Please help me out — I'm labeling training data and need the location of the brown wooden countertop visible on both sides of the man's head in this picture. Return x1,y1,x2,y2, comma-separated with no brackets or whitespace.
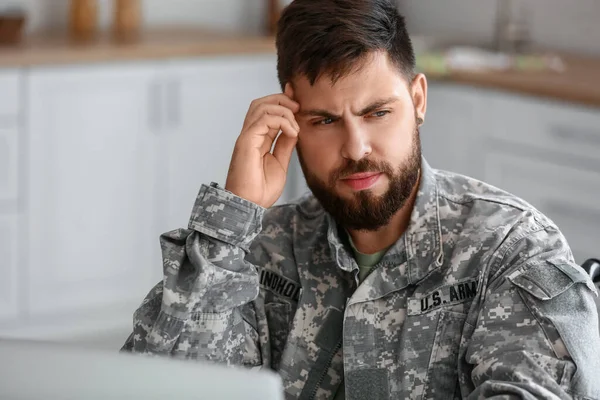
0,29,600,107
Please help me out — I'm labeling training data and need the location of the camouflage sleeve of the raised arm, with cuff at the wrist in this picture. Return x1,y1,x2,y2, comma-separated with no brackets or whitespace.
122,183,269,366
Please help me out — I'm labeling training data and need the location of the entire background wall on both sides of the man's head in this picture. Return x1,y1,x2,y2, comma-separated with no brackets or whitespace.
7,0,600,55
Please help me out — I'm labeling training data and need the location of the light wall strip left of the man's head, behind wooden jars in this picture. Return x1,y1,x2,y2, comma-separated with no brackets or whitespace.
0,0,266,33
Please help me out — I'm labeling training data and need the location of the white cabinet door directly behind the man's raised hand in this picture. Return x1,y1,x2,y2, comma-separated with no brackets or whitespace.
166,55,281,227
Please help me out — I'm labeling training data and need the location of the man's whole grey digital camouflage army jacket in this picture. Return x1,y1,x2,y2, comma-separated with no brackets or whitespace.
123,160,600,399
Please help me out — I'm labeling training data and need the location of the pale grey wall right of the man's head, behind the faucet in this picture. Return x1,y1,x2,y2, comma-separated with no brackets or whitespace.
398,0,600,56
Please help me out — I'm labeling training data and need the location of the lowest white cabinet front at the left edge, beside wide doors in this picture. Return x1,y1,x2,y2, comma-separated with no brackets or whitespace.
0,215,22,326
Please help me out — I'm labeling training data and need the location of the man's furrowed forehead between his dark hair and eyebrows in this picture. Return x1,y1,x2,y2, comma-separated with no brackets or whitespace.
293,52,411,109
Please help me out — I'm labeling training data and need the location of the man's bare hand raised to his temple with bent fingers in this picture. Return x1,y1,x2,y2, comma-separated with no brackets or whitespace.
225,83,300,208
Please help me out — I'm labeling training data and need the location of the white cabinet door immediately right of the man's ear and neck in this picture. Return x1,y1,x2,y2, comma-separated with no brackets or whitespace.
421,82,485,179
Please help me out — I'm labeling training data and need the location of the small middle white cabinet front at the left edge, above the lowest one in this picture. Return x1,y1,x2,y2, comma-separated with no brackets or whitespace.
0,127,19,205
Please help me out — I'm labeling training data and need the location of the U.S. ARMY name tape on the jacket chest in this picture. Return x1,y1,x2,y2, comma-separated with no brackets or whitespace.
408,277,479,315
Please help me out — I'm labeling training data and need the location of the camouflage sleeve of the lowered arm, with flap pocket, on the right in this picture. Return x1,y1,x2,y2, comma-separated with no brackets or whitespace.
466,223,600,399
